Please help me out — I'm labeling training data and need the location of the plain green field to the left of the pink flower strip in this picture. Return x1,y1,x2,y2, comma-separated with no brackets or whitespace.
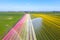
0,12,24,40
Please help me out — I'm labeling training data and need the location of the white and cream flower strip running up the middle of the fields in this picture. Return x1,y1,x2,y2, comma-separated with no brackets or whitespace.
28,14,36,40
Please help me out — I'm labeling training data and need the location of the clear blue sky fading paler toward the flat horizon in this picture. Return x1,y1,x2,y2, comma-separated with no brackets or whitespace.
0,0,60,11
